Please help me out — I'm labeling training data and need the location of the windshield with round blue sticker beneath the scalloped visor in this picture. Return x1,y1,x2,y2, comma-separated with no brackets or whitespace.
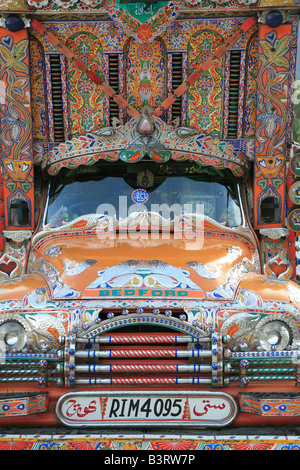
45,161,242,227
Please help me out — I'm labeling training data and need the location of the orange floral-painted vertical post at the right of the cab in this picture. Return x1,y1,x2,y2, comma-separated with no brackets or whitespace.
254,25,291,228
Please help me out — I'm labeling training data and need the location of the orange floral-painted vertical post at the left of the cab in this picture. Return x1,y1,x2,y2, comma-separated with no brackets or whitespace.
0,29,34,228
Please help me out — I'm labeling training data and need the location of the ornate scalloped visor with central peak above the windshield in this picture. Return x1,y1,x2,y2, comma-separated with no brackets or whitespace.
42,113,249,177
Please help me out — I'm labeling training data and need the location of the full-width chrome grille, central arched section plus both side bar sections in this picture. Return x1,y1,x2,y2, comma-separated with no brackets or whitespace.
0,309,300,388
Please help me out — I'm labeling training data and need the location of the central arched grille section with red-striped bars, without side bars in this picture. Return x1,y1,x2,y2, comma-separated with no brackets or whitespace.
61,313,223,386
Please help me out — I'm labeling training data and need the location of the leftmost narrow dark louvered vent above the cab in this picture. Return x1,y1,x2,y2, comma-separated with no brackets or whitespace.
50,54,65,142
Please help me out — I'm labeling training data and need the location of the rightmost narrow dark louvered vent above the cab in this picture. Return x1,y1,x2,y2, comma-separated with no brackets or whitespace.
227,51,241,139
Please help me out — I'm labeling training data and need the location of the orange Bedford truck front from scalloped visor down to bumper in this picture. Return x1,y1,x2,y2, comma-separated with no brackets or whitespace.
0,113,300,429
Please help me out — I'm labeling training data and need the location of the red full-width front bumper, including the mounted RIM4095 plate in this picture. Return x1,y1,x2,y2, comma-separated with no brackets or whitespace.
0,382,300,433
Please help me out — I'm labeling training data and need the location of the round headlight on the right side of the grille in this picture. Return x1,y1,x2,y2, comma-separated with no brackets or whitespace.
259,320,291,351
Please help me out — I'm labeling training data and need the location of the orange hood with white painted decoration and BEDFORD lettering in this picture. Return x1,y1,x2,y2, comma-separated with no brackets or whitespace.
30,223,259,300
